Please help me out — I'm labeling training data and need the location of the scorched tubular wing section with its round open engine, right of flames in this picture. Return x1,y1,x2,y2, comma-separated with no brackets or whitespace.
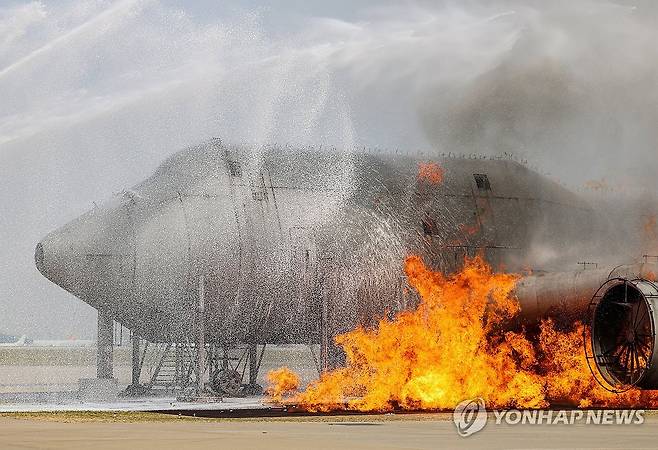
516,263,658,392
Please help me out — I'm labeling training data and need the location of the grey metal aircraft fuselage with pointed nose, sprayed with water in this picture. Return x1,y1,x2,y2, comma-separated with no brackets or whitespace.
36,141,599,345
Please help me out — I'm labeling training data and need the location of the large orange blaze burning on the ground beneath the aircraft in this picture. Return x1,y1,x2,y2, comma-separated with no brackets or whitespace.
268,256,658,411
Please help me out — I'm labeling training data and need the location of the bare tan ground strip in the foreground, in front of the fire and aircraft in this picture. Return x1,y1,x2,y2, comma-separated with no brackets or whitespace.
0,413,658,449
